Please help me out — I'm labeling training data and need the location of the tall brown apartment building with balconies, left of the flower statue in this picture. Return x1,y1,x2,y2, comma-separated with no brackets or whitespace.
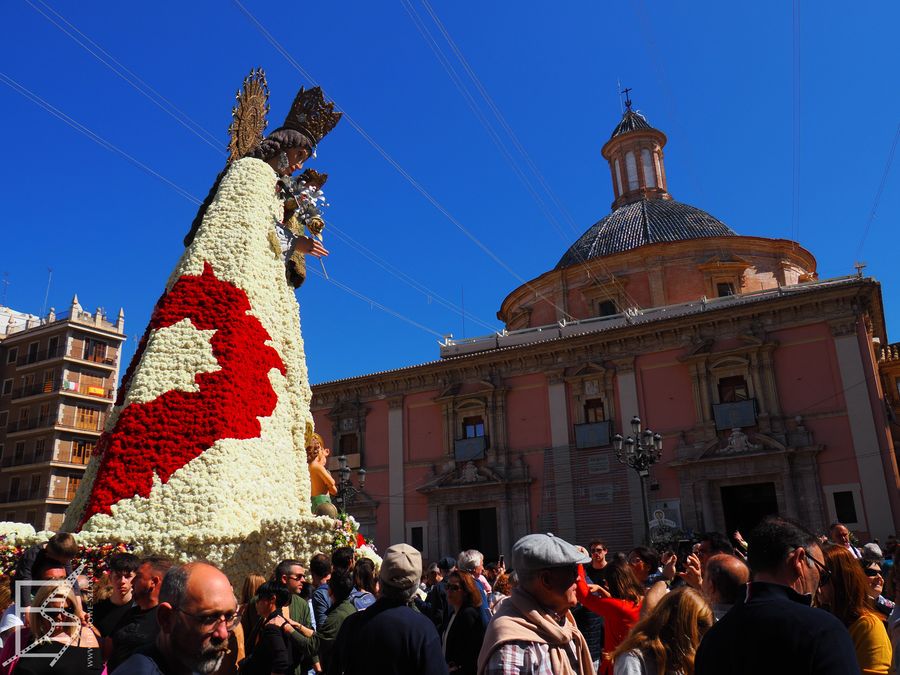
0,295,126,530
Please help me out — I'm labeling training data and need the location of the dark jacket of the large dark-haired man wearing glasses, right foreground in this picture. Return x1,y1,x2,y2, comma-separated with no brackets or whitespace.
694,581,860,675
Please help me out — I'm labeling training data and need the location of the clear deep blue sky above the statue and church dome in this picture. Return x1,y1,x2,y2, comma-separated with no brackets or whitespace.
0,0,900,383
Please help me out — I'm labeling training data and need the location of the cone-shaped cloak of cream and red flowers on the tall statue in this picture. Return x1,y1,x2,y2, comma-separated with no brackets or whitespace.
57,158,334,579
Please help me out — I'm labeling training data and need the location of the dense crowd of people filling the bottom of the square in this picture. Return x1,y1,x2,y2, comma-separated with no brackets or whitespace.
0,516,900,675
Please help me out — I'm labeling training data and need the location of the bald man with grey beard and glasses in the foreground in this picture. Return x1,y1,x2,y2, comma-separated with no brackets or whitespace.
114,562,240,675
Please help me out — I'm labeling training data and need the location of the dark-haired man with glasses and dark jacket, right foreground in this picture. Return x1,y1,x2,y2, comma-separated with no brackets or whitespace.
694,516,860,675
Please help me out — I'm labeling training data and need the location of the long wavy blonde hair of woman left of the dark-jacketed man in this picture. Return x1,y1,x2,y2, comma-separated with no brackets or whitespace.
613,588,714,675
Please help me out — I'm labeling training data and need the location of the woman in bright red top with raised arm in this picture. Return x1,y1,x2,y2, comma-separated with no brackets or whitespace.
577,559,644,675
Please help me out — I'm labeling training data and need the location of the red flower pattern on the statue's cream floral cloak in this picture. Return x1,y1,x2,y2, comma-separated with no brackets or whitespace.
81,262,285,525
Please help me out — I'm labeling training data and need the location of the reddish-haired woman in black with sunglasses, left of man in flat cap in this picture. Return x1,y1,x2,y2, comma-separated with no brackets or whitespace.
441,570,484,675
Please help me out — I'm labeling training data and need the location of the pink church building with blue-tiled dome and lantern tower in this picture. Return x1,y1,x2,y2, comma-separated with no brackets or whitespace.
313,110,900,560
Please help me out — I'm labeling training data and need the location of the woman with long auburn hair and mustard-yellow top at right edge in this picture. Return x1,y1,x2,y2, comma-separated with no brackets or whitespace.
819,546,892,675
